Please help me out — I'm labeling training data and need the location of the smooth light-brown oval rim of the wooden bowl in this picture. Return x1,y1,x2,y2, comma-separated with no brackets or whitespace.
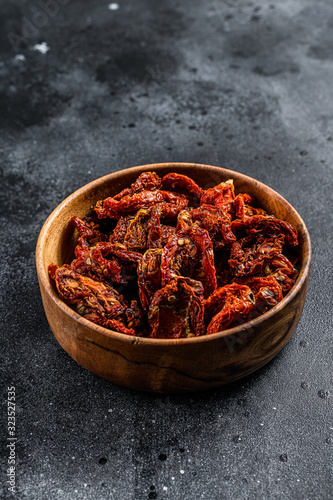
36,162,312,347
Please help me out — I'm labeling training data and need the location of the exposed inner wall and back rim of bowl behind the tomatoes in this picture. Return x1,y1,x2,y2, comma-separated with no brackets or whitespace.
37,163,311,332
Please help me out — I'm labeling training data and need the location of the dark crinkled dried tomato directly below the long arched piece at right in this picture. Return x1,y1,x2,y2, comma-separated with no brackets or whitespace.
228,234,284,278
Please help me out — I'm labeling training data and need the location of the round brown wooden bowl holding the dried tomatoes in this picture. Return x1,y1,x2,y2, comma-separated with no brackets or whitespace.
36,163,311,393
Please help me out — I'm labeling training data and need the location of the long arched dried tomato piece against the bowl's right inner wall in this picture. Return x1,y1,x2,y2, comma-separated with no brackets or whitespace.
231,215,298,247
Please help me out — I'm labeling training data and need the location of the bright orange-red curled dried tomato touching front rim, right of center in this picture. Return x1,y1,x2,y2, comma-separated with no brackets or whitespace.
204,283,255,335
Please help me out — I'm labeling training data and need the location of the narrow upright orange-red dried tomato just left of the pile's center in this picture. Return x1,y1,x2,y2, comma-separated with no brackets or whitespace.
138,248,162,311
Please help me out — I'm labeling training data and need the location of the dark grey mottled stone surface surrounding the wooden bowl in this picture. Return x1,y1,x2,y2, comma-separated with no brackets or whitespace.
0,0,333,500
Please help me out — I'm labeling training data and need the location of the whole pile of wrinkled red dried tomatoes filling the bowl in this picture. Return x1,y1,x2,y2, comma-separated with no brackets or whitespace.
49,172,298,338
